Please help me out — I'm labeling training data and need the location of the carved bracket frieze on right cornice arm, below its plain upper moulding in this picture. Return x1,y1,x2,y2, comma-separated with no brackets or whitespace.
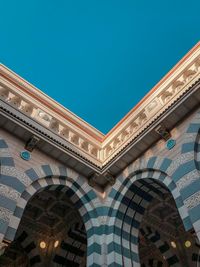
103,55,200,164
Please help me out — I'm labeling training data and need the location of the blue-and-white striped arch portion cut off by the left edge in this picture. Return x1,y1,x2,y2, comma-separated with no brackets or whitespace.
0,137,15,243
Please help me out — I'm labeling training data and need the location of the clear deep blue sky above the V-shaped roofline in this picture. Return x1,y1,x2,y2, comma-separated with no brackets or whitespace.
0,0,200,133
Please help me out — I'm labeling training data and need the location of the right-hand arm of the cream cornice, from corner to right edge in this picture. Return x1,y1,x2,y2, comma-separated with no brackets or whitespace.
102,43,200,165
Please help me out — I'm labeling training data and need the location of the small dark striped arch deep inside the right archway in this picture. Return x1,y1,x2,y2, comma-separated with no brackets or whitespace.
140,226,181,267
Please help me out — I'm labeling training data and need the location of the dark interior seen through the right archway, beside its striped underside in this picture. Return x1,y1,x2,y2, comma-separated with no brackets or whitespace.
135,179,200,267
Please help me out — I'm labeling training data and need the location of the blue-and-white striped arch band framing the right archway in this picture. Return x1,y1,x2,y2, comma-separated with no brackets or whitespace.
108,157,193,230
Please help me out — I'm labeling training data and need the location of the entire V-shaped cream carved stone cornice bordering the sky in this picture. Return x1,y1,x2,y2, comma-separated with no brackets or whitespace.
0,43,200,168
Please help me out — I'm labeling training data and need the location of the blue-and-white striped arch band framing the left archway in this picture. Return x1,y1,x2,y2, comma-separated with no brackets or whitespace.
0,165,99,265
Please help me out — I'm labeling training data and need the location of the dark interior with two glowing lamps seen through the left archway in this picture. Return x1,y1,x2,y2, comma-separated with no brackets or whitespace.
0,186,87,267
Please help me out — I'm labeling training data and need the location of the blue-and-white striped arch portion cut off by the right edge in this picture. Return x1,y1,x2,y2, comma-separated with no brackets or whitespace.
180,112,200,240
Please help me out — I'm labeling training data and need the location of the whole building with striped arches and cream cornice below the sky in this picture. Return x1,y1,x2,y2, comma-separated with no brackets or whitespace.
0,43,200,267
